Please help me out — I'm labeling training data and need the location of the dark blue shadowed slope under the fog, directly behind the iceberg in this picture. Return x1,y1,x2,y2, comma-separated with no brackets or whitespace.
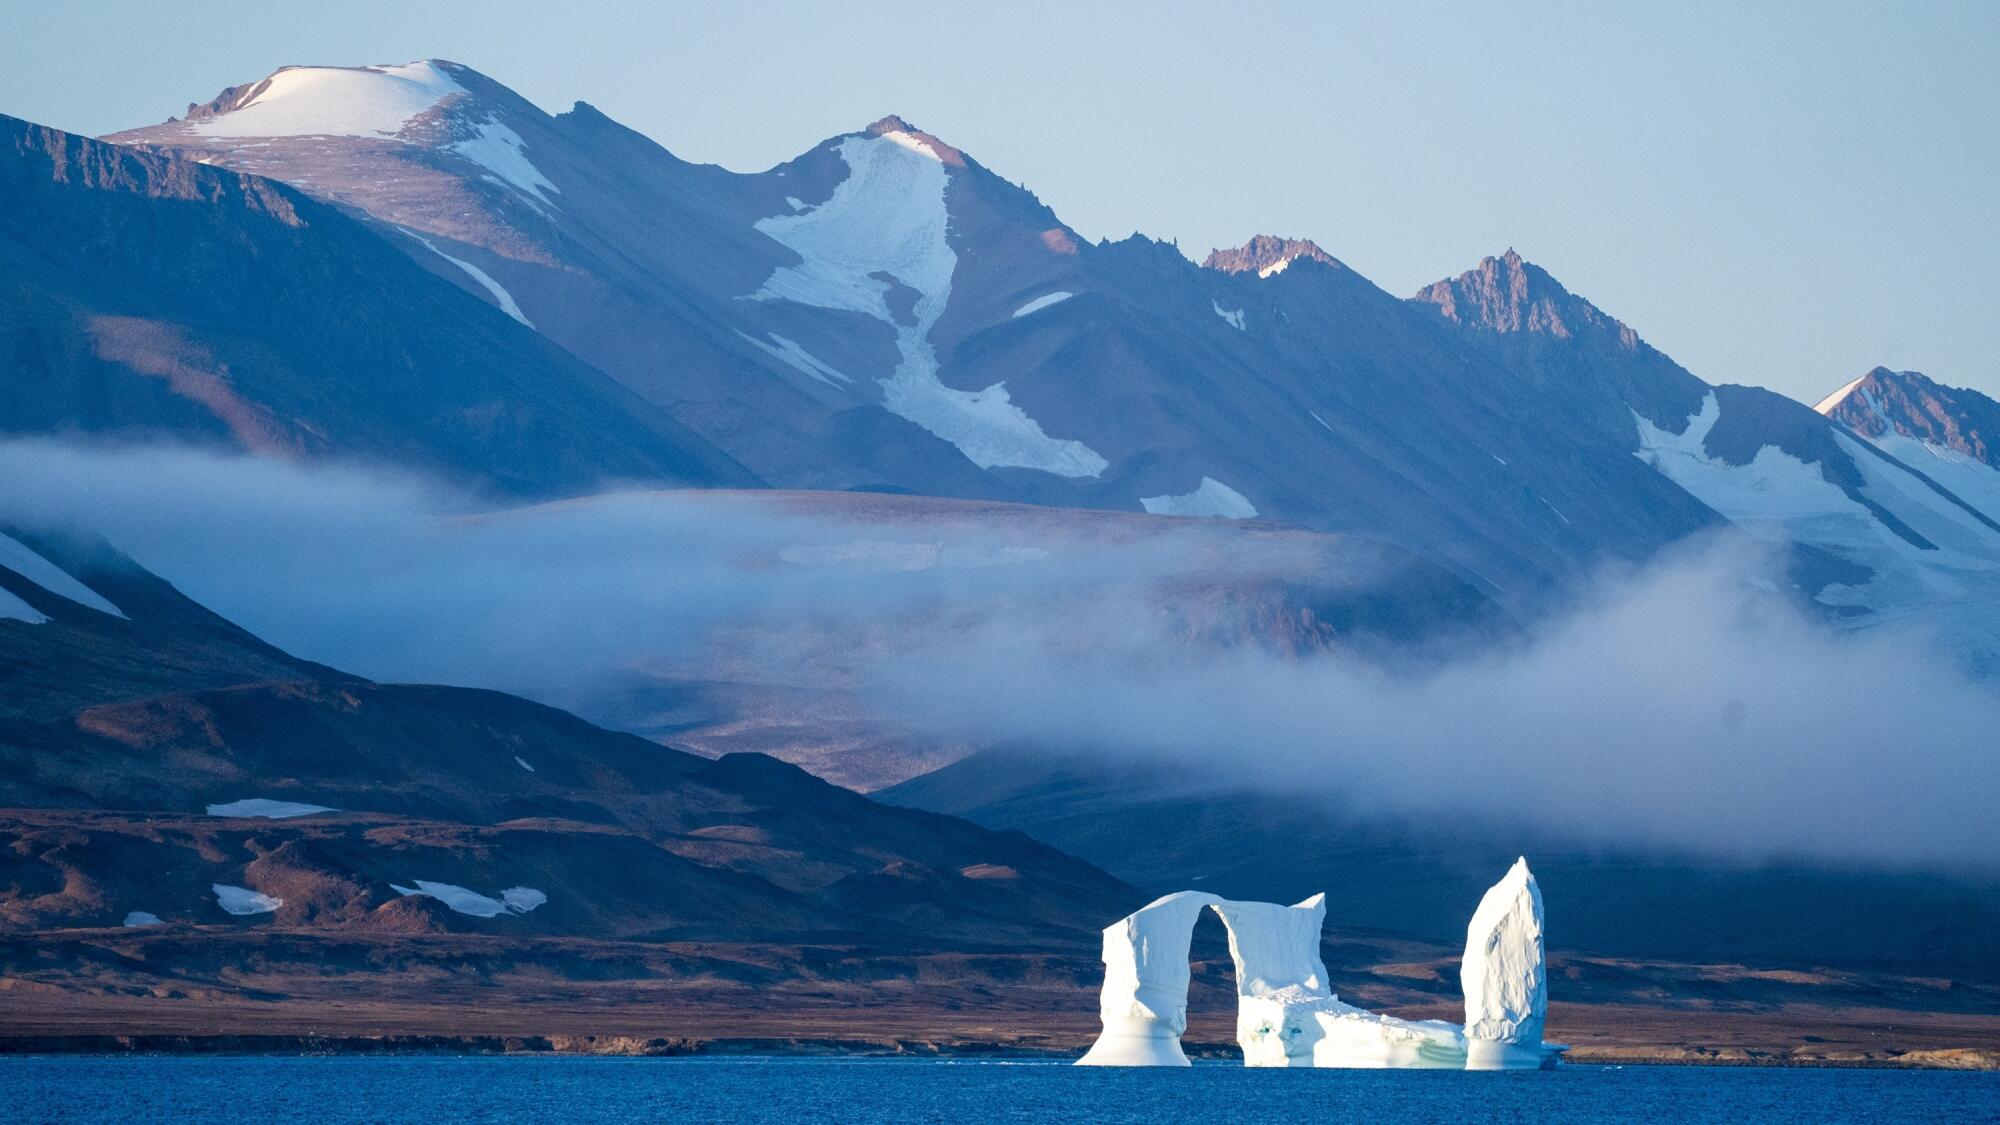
878,745,2000,971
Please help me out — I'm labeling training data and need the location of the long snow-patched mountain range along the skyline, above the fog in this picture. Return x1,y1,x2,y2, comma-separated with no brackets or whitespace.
90,60,2000,656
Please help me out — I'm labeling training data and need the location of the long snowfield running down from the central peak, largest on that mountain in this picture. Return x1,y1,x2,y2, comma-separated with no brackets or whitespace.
752,132,1110,476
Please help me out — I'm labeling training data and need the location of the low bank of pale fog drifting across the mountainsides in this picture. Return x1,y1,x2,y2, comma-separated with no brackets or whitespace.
0,440,2000,867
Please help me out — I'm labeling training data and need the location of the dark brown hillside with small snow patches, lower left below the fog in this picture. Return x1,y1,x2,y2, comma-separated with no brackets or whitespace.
0,528,1136,940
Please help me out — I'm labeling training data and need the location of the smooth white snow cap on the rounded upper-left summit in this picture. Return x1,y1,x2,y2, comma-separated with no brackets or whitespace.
188,60,466,138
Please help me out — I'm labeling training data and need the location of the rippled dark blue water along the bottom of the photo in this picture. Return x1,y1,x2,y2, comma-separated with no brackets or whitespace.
0,1057,2000,1125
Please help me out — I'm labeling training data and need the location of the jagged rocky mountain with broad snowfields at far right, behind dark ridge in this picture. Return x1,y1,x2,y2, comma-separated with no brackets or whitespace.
1414,252,2000,660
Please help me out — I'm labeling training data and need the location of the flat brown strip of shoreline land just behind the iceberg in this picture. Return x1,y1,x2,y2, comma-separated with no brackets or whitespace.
0,927,2000,1069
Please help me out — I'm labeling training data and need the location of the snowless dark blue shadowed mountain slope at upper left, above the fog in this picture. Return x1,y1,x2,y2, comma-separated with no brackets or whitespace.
0,118,756,494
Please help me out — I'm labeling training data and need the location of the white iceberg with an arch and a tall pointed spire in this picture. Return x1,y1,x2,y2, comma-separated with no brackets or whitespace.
1076,859,1564,1071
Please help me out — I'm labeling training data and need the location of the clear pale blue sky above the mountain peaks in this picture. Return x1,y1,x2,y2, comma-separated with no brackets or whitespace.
0,0,2000,402
